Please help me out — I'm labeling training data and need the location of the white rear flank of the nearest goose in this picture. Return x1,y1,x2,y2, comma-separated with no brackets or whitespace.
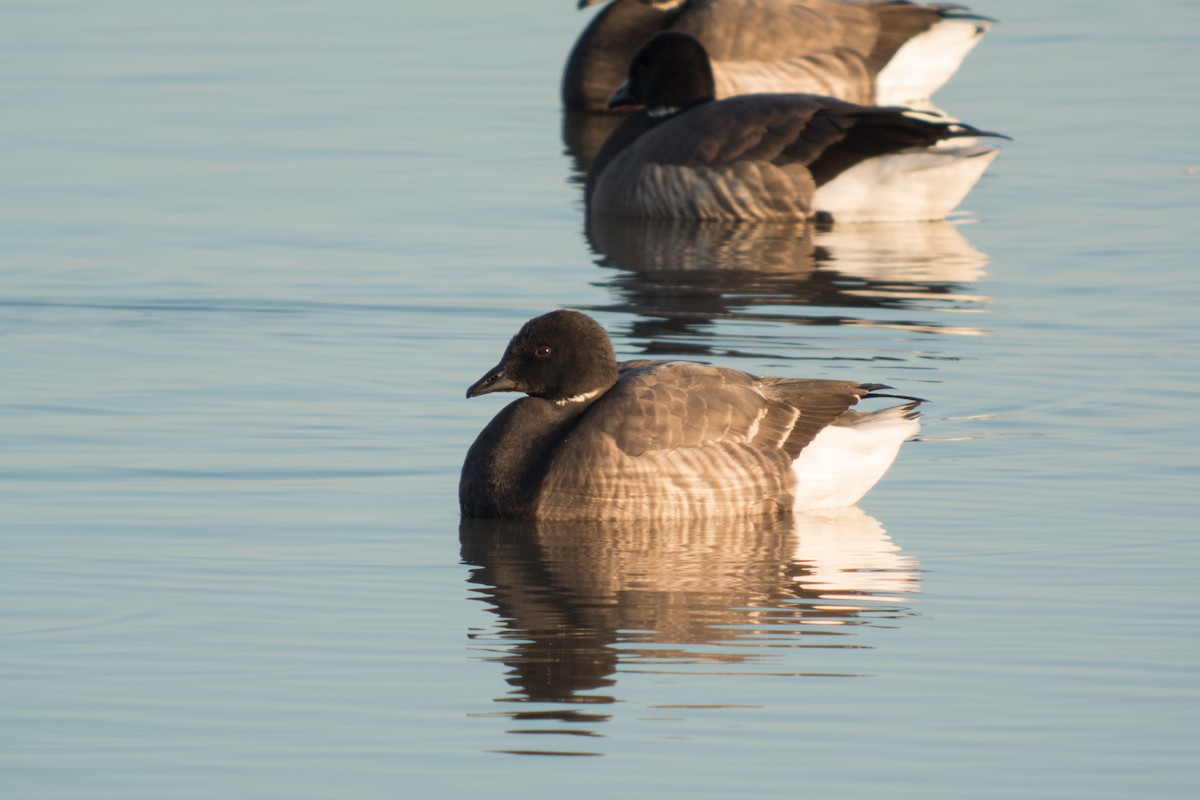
792,405,920,511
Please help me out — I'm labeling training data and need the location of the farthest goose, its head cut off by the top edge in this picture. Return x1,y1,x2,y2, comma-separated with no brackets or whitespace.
562,0,991,110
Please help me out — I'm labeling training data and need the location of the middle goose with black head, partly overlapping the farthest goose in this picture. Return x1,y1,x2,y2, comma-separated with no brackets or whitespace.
586,31,1003,222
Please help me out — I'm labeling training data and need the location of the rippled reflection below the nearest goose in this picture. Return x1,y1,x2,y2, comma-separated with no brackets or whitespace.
460,509,919,753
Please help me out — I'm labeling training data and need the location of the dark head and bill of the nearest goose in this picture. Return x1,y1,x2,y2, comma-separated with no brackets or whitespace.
467,311,617,402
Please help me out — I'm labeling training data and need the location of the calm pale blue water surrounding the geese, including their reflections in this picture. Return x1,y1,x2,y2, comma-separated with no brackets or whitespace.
0,0,1200,800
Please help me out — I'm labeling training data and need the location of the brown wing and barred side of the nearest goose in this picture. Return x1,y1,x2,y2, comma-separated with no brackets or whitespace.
539,362,865,518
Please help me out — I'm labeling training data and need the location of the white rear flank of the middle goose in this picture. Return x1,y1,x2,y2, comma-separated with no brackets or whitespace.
812,145,1000,222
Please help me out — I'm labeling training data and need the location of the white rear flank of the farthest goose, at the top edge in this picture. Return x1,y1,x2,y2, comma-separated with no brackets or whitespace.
875,18,988,106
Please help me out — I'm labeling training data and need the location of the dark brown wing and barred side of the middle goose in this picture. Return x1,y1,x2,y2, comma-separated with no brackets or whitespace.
589,94,990,219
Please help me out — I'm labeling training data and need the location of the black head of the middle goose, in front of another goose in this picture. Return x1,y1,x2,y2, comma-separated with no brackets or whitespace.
608,31,716,114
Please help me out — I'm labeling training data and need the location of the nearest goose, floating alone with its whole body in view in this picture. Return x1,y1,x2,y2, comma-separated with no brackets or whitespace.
458,311,920,519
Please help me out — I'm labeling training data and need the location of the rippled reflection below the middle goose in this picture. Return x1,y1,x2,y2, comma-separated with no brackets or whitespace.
586,215,988,354
